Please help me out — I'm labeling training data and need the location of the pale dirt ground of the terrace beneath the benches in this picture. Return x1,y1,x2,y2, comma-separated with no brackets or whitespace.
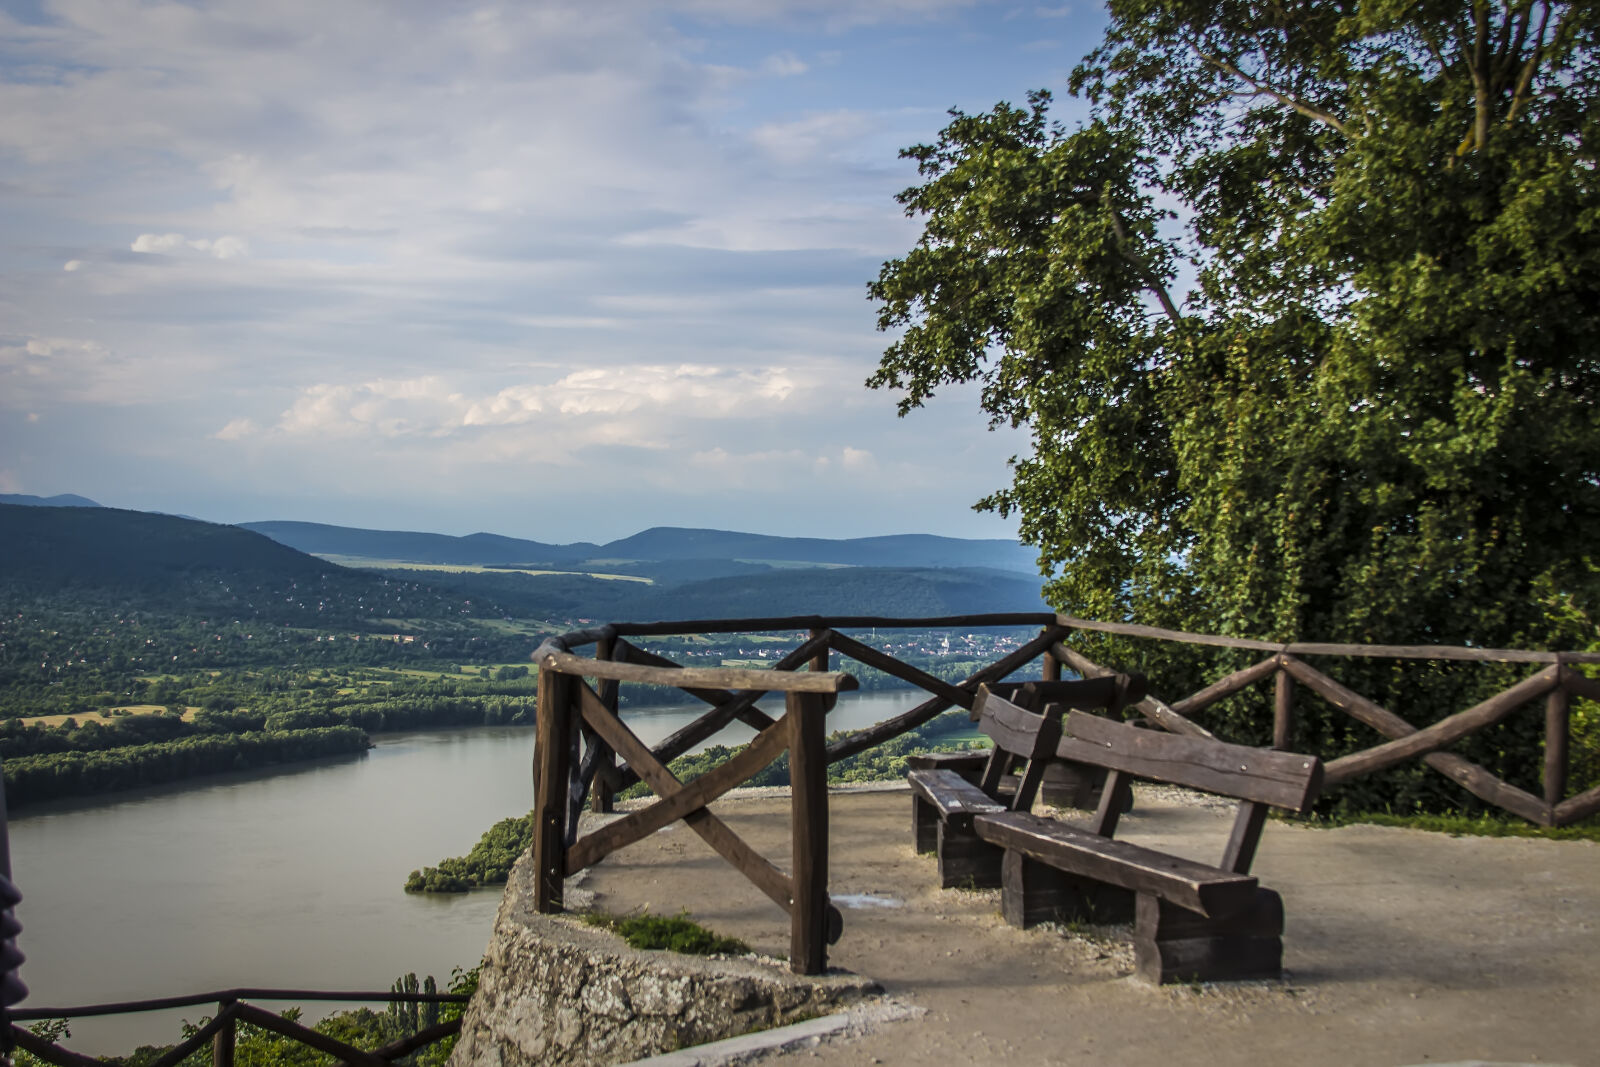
586,789,1600,1067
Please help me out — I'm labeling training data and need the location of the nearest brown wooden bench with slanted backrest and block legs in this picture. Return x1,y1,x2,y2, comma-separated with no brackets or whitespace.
972,710,1322,982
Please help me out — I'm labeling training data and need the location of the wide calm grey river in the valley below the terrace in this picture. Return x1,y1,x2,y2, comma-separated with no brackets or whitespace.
11,689,926,1054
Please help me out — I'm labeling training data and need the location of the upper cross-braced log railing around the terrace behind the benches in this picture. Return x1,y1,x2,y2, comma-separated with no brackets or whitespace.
533,613,1600,974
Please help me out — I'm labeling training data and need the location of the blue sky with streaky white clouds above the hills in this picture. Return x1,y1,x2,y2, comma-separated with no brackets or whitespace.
0,0,1104,542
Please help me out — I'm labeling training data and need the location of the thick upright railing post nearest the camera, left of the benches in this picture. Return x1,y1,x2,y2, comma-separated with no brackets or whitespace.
786,693,829,974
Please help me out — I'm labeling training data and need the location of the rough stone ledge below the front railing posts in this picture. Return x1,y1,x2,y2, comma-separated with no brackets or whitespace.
450,856,878,1067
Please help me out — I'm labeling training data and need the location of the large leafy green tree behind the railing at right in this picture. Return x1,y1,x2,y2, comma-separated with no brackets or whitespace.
869,0,1600,648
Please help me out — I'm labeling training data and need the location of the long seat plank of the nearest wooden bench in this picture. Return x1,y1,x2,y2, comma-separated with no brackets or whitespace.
973,811,1256,918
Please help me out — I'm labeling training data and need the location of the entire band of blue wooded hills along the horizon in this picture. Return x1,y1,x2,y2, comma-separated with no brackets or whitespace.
0,498,1048,624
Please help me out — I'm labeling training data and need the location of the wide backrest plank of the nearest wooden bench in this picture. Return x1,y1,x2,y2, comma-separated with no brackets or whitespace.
1056,712,1322,811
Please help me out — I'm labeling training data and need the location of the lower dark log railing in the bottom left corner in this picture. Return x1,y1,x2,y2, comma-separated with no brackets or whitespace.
8,989,470,1067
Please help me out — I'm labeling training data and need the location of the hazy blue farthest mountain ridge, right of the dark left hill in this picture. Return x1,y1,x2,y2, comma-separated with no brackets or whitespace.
240,522,1035,574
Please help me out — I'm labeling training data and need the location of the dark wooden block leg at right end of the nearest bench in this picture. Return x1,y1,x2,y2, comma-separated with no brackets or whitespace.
1133,889,1283,984
